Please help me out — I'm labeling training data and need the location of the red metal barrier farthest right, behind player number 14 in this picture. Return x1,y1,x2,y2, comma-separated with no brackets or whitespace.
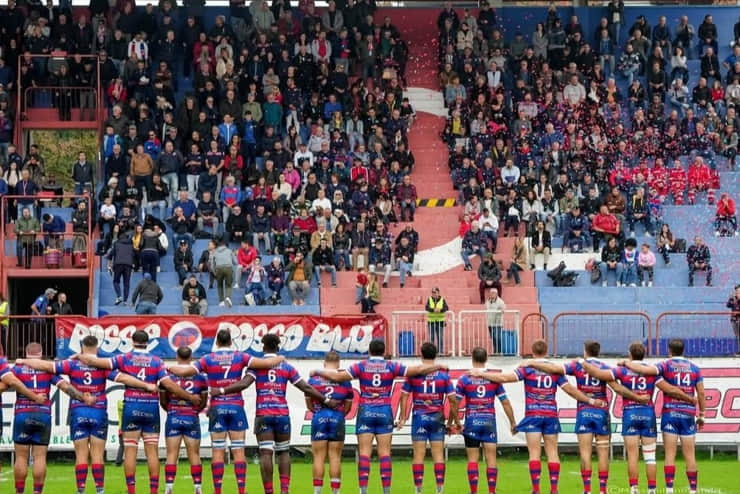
655,312,740,357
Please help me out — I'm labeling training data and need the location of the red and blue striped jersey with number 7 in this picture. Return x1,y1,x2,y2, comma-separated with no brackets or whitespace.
191,348,252,407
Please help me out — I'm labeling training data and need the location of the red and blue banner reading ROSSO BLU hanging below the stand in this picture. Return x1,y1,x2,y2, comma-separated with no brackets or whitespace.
56,315,386,359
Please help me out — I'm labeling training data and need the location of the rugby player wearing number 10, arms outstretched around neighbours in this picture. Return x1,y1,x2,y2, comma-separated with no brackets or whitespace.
471,340,607,494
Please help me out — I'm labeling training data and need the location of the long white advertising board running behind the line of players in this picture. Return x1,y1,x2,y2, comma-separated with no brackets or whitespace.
0,359,740,453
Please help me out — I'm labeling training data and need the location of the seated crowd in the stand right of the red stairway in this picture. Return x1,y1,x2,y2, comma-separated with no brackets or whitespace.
437,1,740,291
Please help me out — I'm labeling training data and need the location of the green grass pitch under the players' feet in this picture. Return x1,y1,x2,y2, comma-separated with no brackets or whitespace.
0,451,740,494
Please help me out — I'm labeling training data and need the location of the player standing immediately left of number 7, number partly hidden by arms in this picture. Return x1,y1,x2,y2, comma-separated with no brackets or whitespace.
159,346,208,494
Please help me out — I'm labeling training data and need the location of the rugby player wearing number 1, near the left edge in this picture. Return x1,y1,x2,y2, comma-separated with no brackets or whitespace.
12,343,95,494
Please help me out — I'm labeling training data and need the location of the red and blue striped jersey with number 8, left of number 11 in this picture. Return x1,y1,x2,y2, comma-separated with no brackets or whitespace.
347,357,406,406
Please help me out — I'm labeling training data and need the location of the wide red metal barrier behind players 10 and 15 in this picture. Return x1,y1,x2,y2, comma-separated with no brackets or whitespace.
550,312,653,355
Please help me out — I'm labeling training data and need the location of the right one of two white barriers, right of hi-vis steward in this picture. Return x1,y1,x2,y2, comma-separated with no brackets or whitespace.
455,310,521,356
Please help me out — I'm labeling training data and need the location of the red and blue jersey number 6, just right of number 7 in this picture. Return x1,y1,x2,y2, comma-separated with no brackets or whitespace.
249,354,303,417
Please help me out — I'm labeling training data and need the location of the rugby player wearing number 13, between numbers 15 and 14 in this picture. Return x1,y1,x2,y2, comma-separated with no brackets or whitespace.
578,342,696,494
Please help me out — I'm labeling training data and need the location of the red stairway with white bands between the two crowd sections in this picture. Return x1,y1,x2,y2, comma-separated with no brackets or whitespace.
321,9,539,332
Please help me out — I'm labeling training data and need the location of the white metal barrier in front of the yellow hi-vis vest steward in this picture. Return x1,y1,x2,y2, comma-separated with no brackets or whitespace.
391,310,457,357
